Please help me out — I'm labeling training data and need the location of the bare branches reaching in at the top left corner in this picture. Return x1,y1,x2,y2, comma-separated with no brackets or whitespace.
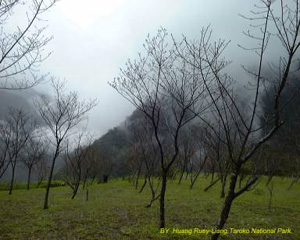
0,0,56,90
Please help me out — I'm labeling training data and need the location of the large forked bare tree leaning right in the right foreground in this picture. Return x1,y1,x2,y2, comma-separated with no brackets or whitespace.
173,0,300,240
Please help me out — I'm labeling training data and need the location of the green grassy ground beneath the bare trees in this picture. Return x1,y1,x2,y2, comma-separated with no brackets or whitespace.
0,175,300,240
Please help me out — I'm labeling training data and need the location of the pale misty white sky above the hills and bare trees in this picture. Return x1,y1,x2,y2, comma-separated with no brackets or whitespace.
2,0,262,136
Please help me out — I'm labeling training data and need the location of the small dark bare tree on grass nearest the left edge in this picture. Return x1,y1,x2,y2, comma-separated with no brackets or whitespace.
1,108,36,194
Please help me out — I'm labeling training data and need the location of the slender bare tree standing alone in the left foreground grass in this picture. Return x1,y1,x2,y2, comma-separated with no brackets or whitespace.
35,81,97,209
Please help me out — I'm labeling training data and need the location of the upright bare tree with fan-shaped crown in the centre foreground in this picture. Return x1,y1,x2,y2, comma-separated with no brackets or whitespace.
111,29,211,228
